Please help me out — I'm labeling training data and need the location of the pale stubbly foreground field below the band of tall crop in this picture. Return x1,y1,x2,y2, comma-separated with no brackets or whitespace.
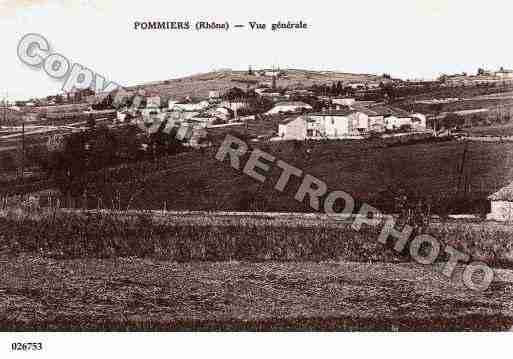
0,256,513,331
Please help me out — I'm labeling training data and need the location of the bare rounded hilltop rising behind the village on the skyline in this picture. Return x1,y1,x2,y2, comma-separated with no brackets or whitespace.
118,69,383,99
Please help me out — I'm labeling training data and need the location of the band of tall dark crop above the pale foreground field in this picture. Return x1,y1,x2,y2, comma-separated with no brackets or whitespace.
0,210,513,268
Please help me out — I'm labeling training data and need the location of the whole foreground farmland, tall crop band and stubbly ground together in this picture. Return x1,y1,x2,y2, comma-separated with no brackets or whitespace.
0,210,513,331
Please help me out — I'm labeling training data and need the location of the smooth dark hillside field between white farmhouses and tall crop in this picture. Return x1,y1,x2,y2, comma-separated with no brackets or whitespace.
75,141,513,213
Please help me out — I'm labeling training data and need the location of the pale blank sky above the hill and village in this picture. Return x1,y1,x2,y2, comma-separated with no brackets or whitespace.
0,0,513,99
